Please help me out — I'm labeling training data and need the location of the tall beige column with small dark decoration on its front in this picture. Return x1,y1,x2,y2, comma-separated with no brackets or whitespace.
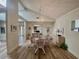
6,0,19,53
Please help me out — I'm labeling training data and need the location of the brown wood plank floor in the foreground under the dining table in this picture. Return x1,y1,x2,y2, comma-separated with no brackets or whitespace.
5,46,77,59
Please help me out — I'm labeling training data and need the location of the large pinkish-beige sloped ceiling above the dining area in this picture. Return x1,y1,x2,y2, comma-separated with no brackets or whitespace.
21,0,79,20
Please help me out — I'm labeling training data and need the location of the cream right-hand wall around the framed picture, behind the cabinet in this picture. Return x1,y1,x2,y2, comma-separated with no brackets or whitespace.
53,8,79,58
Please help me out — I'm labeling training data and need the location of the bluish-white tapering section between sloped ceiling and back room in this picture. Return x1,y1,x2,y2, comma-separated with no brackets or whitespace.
18,3,53,22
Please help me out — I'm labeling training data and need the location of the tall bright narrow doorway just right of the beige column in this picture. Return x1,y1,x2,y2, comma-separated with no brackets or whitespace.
19,21,25,46
